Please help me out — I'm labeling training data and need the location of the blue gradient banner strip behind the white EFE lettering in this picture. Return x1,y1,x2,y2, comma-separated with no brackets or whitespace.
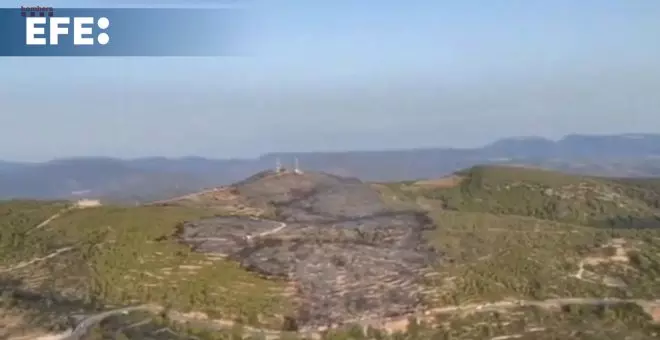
0,7,241,57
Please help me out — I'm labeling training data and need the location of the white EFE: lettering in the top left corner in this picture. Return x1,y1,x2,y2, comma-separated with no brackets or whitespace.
25,17,110,45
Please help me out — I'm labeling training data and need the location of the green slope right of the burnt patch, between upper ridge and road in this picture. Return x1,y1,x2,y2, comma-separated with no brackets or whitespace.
429,211,660,305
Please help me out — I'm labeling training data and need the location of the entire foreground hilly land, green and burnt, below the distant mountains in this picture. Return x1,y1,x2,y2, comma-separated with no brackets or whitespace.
0,166,660,339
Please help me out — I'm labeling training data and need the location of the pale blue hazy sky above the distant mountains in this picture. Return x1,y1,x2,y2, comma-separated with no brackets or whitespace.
0,0,660,161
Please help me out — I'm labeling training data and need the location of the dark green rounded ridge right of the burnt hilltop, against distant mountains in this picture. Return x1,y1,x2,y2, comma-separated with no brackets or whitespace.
395,166,660,227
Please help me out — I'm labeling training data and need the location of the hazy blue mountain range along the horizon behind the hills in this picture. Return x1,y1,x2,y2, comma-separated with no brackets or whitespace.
0,134,660,202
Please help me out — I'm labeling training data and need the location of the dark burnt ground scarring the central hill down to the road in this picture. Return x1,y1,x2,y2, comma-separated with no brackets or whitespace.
173,172,438,329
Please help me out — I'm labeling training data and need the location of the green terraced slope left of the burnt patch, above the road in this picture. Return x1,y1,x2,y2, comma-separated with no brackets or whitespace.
0,202,286,334
